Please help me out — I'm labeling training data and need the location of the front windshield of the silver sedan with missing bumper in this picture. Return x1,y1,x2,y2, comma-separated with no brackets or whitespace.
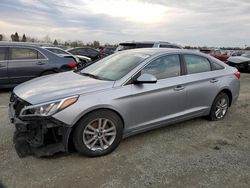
80,52,149,81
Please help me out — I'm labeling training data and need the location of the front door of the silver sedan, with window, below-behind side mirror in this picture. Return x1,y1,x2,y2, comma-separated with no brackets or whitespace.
130,55,186,131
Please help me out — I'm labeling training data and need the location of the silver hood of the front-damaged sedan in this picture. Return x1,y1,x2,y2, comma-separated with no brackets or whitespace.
14,71,114,104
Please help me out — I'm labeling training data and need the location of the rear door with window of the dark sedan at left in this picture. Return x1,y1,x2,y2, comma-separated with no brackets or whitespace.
8,47,48,84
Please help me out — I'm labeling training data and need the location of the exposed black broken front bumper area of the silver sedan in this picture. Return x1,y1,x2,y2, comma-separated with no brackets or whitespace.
9,94,71,157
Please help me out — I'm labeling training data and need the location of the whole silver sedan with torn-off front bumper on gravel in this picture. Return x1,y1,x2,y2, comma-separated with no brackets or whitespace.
9,49,240,157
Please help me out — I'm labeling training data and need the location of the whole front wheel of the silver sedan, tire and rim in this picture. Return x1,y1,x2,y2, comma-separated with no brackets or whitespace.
73,110,123,157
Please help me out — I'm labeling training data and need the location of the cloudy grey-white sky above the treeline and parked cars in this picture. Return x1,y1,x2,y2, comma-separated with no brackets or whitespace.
0,0,250,47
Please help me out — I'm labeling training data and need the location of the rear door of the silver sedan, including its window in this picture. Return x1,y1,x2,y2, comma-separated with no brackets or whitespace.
183,54,220,113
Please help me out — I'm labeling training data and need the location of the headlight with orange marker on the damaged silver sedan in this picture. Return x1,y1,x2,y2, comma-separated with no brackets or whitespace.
20,96,79,117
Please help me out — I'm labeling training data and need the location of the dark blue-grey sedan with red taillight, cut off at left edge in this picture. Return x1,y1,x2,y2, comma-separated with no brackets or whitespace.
0,42,76,88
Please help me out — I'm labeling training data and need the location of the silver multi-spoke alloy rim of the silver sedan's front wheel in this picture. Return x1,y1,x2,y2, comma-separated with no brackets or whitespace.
83,118,116,151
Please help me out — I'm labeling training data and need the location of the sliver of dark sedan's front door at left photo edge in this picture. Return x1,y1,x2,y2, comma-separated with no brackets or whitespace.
0,47,9,85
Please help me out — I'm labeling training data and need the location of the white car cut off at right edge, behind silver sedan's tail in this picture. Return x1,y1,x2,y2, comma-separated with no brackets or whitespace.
226,52,250,72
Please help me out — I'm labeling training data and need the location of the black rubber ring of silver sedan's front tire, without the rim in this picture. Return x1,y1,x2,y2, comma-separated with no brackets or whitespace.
73,110,123,157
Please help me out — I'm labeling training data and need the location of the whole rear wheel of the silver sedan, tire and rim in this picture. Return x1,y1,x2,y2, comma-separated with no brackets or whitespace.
209,93,229,121
